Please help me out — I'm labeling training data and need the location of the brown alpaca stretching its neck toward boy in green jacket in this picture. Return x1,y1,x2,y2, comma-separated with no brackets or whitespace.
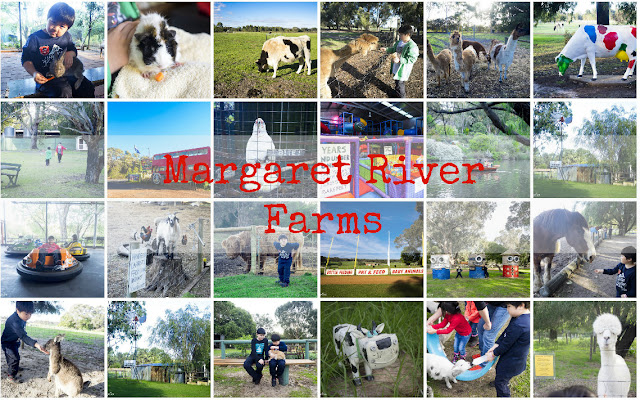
320,33,378,99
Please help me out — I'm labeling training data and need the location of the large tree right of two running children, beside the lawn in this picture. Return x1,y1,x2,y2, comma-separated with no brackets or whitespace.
54,102,104,183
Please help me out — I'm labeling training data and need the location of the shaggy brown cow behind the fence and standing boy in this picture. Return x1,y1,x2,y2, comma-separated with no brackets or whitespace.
222,225,304,275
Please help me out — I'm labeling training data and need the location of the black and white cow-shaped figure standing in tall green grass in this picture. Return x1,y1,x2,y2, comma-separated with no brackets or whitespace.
333,322,399,386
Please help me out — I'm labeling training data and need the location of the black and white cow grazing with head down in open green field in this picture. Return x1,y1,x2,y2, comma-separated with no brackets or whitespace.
256,35,311,78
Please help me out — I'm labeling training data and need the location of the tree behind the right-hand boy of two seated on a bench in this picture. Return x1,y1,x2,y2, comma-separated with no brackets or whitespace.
275,301,318,339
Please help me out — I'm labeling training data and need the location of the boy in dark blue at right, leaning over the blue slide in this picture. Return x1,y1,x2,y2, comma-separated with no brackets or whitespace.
486,301,531,397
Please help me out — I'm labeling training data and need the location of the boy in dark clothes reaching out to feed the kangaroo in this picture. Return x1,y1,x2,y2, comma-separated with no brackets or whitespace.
1,301,49,383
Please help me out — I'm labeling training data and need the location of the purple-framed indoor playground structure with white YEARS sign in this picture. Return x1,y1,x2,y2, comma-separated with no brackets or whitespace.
320,135,425,198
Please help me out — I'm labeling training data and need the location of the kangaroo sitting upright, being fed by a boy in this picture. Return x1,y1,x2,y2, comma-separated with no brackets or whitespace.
44,334,91,397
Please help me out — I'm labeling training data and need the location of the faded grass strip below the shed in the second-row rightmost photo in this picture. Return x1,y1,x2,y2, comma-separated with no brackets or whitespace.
533,178,636,198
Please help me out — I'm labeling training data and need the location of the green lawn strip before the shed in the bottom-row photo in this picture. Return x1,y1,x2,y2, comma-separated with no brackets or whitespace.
108,378,211,397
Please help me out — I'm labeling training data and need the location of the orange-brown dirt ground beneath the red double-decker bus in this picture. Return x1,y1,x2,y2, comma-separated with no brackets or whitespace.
107,179,211,199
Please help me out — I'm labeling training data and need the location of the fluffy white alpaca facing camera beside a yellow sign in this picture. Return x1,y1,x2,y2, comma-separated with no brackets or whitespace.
593,314,631,397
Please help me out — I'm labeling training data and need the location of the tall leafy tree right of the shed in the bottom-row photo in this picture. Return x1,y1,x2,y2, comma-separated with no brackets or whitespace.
150,304,211,371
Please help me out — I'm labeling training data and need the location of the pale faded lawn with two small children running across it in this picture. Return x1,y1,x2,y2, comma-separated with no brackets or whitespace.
2,150,104,198
